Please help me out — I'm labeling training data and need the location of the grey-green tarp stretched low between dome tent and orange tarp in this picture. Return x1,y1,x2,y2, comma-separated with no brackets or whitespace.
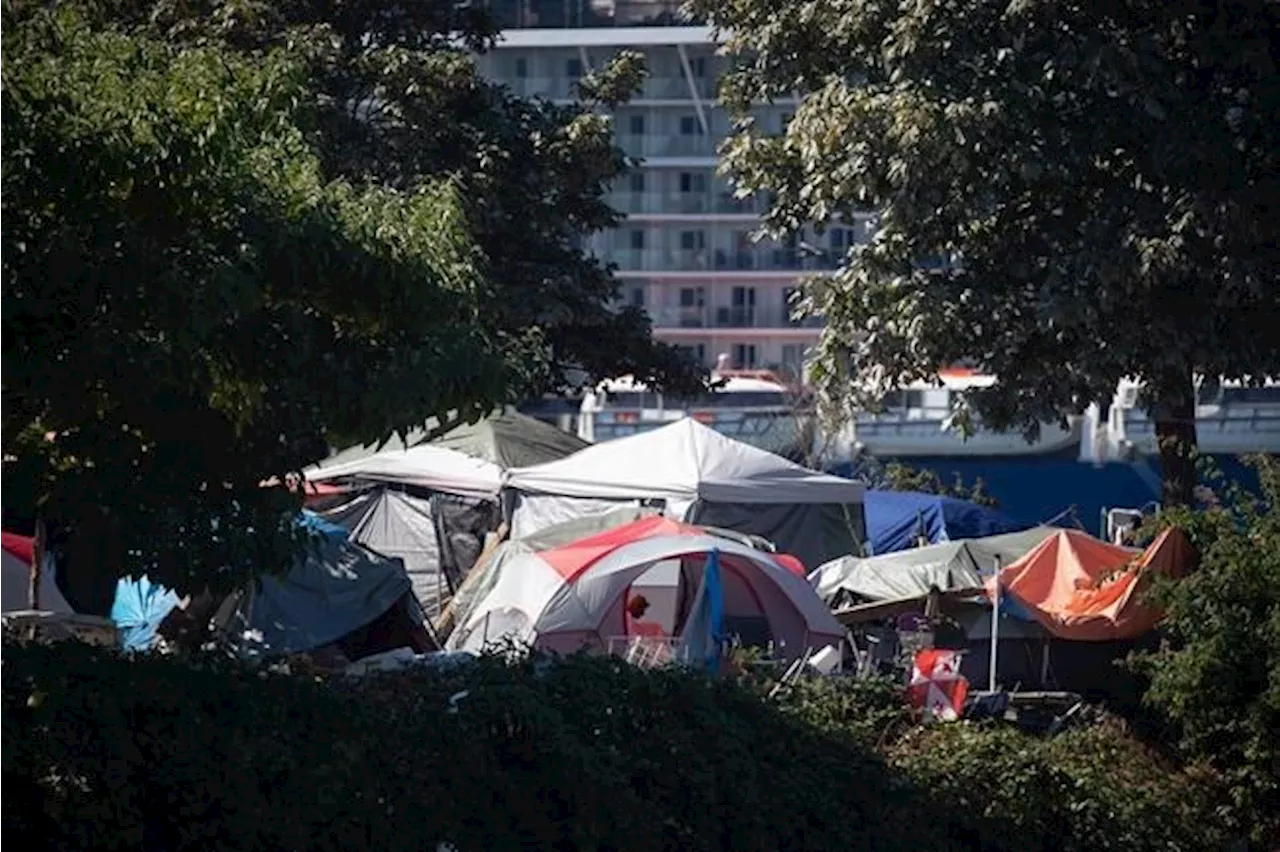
809,527,1059,604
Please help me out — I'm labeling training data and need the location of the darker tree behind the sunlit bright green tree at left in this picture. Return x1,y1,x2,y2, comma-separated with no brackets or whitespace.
120,0,701,411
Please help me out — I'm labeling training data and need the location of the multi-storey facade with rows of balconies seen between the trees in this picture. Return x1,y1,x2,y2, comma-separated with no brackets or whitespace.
479,0,872,375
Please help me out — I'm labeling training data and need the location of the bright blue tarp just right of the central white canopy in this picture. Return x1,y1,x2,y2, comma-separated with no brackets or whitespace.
863,490,1028,556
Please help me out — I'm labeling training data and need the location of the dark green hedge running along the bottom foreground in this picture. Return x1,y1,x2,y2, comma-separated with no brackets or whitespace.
0,645,1239,852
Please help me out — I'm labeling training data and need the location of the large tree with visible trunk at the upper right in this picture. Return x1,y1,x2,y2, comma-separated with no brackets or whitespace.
692,0,1280,504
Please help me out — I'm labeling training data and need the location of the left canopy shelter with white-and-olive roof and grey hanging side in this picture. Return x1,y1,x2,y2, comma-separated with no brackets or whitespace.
307,412,586,615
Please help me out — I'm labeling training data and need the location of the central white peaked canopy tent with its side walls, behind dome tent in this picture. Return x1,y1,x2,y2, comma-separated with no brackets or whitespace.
507,417,865,567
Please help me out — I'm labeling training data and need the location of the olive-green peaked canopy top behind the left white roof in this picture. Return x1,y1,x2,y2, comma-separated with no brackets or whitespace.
321,411,590,469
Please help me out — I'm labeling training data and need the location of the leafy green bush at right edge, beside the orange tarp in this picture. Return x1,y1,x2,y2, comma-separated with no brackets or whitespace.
1134,458,1280,842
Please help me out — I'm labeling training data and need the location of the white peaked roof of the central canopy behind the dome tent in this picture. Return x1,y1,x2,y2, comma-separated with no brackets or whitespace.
507,417,865,504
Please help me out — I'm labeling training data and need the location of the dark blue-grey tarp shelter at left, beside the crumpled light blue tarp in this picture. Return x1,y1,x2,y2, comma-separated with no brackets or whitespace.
216,512,412,656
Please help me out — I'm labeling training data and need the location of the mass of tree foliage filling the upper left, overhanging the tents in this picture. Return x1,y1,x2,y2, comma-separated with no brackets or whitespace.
0,0,698,587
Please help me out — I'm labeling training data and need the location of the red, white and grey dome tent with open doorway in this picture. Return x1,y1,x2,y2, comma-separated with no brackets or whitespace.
448,517,845,659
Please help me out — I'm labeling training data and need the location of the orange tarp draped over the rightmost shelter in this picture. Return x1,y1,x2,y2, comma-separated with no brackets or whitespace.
988,528,1194,642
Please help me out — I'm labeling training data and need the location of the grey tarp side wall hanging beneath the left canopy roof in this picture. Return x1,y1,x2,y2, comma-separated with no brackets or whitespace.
324,487,498,617
